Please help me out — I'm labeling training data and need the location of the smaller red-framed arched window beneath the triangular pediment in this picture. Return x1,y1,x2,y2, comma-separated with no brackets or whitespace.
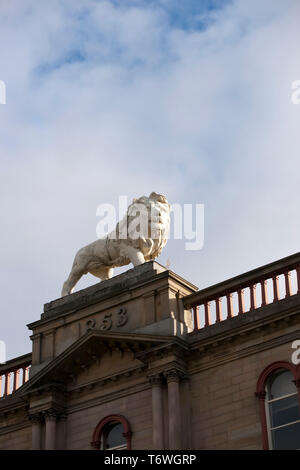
91,415,132,450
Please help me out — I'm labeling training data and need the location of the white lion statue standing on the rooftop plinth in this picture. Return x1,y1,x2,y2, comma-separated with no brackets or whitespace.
61,192,170,296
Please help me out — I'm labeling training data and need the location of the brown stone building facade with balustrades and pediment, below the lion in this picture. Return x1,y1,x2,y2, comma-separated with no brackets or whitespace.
0,253,300,450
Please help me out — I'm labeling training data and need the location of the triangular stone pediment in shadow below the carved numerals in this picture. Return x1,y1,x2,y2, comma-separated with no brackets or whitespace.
16,330,176,396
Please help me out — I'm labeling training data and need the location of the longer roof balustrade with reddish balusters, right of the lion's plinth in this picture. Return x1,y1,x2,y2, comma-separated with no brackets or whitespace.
183,253,300,331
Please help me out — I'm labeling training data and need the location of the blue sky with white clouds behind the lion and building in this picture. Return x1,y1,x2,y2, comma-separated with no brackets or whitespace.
0,0,300,358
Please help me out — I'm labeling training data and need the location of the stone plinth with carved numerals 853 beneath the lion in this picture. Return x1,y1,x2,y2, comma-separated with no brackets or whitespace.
28,261,197,376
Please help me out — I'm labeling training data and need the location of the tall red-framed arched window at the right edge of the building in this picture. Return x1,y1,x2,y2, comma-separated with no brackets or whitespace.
256,361,300,450
